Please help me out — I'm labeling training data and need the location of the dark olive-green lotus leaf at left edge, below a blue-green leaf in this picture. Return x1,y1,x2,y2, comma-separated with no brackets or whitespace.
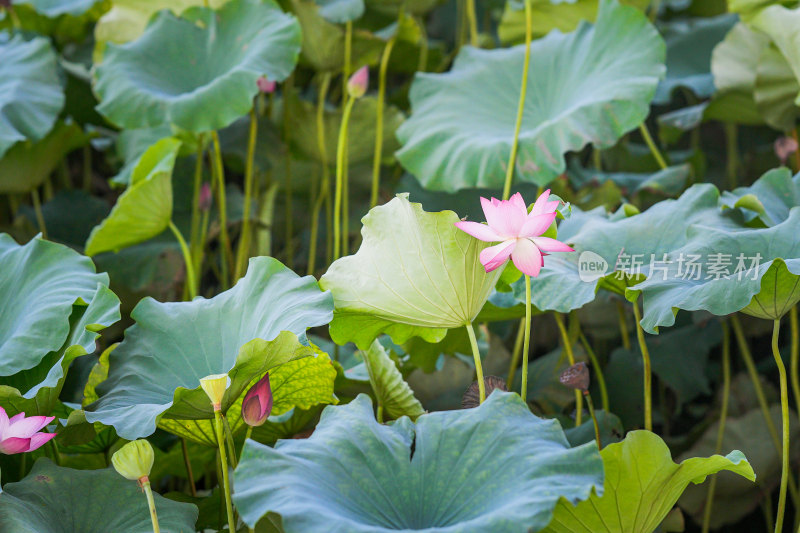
0,122,88,193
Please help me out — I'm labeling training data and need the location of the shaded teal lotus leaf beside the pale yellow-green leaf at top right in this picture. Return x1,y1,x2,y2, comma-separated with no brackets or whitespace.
653,13,738,104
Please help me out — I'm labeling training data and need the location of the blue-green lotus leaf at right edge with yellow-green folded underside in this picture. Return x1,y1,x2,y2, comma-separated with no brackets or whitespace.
628,208,800,332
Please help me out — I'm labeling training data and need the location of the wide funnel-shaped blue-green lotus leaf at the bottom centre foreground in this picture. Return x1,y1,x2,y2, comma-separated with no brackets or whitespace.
234,392,603,533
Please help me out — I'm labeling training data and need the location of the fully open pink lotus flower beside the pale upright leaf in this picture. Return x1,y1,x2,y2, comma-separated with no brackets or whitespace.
456,189,575,277
